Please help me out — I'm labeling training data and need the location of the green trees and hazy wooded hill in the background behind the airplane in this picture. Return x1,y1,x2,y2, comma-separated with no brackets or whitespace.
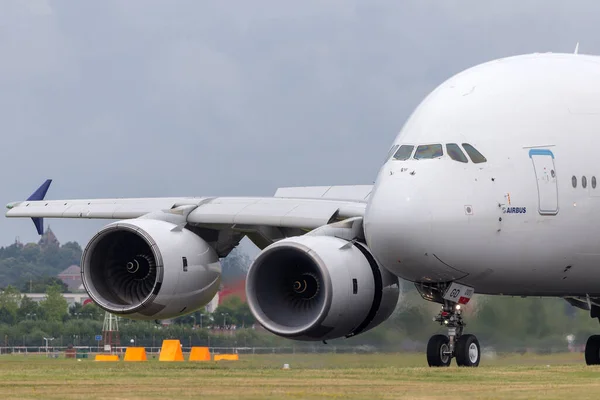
0,242,600,350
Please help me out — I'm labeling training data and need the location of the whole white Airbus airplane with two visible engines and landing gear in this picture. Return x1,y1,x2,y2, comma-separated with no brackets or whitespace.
6,53,600,367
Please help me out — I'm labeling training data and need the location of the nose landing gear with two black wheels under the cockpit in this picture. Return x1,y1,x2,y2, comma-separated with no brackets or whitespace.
417,283,480,367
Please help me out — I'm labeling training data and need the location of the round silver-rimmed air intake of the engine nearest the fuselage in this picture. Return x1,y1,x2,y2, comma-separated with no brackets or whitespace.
246,241,332,338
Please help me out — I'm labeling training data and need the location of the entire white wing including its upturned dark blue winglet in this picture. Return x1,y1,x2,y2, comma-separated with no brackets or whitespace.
6,180,372,250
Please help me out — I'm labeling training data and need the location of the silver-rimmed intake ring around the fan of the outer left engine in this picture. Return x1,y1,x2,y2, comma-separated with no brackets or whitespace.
81,222,164,315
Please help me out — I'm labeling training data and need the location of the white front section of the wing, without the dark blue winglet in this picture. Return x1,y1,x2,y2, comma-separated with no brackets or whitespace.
6,197,366,229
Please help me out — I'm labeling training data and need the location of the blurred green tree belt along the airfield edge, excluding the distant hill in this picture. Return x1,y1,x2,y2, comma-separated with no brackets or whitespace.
0,284,600,351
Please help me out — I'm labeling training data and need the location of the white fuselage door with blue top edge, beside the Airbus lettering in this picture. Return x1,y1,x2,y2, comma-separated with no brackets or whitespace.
529,149,558,215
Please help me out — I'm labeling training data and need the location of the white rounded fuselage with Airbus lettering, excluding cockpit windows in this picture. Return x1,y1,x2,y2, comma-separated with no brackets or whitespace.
364,54,600,296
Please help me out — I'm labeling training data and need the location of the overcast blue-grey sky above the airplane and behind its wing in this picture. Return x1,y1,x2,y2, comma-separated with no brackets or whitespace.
0,0,600,245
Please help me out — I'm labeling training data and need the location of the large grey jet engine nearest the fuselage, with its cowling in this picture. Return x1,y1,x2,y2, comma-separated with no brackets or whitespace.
246,236,399,340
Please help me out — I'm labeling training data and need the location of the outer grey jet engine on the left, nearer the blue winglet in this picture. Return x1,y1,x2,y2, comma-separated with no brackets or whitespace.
81,219,221,319
